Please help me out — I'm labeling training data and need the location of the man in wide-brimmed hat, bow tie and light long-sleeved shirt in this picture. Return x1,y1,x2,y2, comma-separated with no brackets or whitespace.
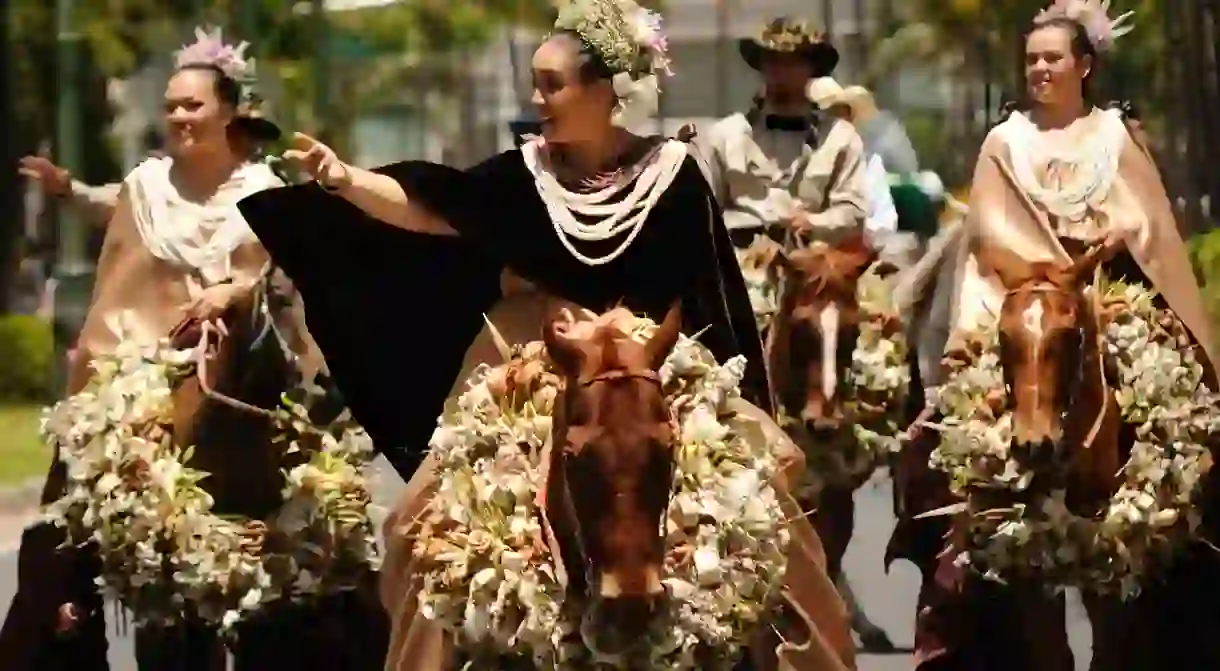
704,18,893,651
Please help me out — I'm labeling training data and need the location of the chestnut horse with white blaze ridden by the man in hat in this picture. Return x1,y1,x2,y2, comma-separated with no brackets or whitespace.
767,233,893,651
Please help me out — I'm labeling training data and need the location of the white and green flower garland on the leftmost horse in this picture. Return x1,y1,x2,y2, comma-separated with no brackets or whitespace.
41,316,379,633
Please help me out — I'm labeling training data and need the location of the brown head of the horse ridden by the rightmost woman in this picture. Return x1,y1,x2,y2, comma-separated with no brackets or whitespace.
988,243,1121,470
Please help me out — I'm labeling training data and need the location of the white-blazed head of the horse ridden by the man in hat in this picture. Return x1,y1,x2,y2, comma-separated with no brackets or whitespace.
775,234,877,431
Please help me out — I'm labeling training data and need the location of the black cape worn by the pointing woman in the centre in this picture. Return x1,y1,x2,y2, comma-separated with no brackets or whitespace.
238,150,771,477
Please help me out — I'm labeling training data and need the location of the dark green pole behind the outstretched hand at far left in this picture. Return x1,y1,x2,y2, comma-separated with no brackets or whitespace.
52,0,94,395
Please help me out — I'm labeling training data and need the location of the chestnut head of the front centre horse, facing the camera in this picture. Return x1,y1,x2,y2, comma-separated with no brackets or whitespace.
543,305,682,655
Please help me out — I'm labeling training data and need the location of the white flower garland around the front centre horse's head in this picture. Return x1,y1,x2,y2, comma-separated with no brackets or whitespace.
415,320,788,671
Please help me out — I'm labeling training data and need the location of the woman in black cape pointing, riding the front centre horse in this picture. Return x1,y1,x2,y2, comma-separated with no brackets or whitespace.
240,0,855,671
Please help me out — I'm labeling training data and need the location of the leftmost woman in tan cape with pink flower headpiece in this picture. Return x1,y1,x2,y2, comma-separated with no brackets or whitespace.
0,28,384,671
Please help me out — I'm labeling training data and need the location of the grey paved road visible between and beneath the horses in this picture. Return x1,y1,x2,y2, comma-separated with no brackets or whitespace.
0,462,1089,671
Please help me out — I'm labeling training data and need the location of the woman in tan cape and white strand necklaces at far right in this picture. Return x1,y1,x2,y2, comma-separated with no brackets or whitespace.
891,1,1220,671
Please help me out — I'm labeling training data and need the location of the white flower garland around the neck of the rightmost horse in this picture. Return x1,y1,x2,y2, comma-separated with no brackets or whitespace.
931,283,1220,598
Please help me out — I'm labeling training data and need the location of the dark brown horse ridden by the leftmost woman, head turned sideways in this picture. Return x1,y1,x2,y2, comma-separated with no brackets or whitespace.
137,272,387,671
